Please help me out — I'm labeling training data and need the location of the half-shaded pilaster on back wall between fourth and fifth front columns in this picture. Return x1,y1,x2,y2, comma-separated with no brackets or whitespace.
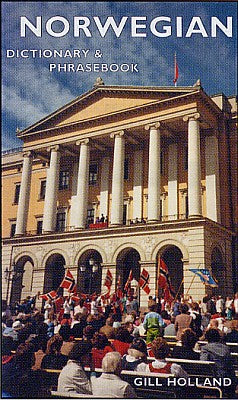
133,150,143,220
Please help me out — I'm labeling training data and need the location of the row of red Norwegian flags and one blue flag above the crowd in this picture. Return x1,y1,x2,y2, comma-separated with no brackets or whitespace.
40,257,218,303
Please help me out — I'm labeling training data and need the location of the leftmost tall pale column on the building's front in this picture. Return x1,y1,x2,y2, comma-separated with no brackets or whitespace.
15,151,32,236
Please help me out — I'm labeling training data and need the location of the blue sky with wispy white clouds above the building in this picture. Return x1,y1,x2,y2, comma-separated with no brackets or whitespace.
2,1,237,150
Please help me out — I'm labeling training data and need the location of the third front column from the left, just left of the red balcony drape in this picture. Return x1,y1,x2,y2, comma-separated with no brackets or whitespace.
75,139,90,229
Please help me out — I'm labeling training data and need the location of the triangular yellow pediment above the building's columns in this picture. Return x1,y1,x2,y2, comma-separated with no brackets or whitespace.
18,86,197,137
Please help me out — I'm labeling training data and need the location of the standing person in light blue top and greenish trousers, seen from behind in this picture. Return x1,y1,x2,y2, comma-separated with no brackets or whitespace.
143,305,165,343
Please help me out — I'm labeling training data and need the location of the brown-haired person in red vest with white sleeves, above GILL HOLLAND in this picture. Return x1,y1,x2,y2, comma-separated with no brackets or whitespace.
137,337,188,378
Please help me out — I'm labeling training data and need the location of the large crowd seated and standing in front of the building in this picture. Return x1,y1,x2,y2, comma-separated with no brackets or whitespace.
2,293,238,398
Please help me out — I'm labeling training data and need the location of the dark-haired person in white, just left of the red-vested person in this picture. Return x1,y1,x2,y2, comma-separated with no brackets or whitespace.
122,338,147,371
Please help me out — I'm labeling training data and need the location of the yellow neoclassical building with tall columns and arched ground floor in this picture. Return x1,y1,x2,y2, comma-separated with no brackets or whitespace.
2,80,237,306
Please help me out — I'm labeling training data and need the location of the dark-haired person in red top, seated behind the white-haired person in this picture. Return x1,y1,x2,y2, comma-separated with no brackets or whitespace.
92,333,113,368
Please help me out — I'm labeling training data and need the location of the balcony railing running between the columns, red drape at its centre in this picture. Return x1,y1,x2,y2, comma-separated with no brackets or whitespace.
6,214,188,237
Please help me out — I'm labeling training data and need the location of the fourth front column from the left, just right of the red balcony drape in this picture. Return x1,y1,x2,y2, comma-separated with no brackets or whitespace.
111,131,125,225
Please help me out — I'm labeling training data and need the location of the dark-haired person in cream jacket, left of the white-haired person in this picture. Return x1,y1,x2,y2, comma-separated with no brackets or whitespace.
57,342,92,394
